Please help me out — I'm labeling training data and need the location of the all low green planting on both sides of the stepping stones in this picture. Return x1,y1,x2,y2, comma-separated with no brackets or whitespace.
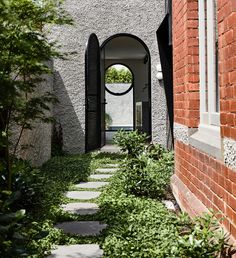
0,132,233,258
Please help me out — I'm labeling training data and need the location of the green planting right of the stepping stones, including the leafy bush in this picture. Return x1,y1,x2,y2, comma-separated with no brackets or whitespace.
99,132,234,258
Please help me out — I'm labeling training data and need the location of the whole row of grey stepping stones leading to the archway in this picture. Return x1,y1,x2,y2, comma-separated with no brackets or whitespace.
48,164,119,258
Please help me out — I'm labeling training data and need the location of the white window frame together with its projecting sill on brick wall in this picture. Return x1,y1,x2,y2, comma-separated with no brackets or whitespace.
189,0,223,160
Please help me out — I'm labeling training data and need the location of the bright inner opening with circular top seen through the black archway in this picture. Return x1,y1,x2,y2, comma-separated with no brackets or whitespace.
105,63,135,144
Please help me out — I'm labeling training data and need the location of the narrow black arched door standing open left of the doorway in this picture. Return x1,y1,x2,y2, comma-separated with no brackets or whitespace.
85,33,101,152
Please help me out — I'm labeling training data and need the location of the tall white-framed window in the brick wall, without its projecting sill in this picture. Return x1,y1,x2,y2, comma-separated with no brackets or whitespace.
198,0,220,127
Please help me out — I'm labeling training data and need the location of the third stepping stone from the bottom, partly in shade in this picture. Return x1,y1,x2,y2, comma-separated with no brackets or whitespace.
62,202,99,215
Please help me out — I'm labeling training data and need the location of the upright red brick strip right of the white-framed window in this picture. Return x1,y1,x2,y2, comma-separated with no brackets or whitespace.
218,0,236,139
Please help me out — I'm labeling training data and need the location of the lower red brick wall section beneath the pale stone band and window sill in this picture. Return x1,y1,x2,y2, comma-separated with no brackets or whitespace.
175,141,236,238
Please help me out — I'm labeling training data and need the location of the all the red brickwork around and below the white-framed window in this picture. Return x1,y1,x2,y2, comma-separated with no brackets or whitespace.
173,0,236,238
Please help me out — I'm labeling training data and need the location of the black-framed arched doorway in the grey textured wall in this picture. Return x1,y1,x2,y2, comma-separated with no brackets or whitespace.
101,33,151,144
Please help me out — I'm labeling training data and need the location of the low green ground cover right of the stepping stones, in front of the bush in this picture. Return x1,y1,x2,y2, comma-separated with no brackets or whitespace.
100,172,234,258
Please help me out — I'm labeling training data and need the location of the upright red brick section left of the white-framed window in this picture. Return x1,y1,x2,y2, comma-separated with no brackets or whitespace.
173,0,199,127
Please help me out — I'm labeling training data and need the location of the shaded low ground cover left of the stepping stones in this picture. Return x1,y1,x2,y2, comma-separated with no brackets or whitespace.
0,153,123,258
